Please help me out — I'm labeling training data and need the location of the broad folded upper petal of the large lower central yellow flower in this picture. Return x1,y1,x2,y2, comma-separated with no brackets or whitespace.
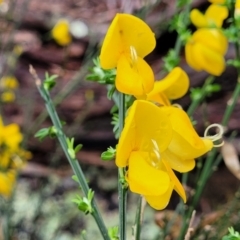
116,100,172,167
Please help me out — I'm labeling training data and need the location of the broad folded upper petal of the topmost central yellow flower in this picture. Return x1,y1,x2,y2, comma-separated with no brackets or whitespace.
100,13,156,69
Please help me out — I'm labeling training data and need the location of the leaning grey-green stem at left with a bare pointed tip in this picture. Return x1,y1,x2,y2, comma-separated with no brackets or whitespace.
30,66,110,240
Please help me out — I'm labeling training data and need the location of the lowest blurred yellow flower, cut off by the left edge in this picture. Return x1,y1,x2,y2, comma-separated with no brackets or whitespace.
0,170,16,198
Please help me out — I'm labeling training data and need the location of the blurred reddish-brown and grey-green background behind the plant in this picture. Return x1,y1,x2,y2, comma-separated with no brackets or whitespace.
0,0,240,240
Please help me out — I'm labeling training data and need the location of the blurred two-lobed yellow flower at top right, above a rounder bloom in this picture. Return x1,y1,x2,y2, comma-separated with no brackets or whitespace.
190,4,228,28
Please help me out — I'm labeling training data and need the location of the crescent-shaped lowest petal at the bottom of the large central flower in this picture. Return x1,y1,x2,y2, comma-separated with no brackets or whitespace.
144,183,173,210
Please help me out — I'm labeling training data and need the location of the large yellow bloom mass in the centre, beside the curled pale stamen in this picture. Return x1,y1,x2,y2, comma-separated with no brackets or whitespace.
116,100,213,209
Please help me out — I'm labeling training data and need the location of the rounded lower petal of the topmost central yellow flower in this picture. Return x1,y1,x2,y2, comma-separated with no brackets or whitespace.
115,54,154,96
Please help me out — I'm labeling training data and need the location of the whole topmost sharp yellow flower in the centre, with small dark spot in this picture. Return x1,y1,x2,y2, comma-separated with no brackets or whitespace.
100,14,156,96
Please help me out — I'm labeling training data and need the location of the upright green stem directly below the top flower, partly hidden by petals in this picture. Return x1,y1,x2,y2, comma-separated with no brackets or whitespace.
118,93,127,240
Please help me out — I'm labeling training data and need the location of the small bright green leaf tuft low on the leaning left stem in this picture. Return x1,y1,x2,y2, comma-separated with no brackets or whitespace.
72,189,94,214
